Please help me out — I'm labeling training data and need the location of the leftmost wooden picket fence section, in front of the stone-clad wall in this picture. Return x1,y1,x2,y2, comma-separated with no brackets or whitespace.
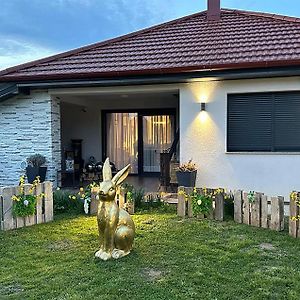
0,181,53,230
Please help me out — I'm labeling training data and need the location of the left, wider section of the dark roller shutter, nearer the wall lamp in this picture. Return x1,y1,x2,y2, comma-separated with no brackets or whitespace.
227,93,272,152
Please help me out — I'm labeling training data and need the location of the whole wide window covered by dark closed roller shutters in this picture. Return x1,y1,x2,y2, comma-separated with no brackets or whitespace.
227,92,300,152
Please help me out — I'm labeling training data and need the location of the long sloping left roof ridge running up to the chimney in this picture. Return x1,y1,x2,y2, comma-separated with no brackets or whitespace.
0,10,207,76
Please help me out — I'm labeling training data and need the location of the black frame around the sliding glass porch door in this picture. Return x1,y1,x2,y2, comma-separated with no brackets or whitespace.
101,107,177,176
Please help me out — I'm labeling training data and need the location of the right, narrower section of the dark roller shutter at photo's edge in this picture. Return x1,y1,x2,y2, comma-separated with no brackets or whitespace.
274,92,300,151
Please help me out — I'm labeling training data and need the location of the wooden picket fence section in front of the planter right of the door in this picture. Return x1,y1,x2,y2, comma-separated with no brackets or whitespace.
177,187,224,221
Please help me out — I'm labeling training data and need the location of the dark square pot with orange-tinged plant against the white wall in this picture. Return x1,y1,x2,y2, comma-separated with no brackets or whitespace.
176,159,197,187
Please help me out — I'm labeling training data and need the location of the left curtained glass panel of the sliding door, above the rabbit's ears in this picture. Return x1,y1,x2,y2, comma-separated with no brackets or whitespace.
106,113,138,174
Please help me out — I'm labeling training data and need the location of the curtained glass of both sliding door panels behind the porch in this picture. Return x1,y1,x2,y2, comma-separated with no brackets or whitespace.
104,112,175,175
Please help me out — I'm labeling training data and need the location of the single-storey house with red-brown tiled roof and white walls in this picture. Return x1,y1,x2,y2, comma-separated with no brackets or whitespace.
0,0,300,199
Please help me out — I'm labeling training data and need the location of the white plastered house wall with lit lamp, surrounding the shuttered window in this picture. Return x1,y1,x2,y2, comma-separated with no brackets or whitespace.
180,77,300,200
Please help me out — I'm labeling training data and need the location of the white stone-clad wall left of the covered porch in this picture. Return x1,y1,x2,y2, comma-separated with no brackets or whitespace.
0,91,61,186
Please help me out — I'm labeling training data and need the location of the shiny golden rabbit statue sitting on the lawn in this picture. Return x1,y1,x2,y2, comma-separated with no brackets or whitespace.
95,158,135,260
